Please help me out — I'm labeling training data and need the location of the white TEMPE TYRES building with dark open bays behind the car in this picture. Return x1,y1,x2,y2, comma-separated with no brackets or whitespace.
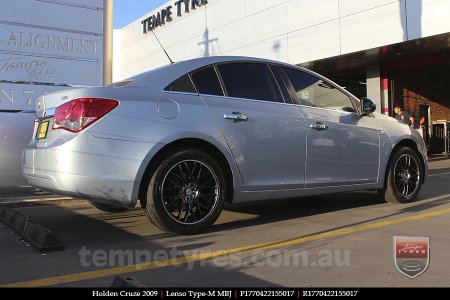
113,0,450,149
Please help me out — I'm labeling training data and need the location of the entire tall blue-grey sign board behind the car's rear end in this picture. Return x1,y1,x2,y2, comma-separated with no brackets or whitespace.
0,0,104,186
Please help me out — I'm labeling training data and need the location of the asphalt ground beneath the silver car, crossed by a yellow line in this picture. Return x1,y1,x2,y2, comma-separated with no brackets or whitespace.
0,159,450,287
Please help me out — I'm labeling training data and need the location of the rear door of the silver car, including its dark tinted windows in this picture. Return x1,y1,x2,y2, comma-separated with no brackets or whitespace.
192,62,306,191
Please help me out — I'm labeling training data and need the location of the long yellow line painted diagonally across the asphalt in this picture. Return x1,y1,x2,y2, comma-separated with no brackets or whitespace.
0,208,450,288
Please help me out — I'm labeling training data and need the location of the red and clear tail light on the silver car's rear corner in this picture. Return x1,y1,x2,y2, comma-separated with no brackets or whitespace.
52,98,119,132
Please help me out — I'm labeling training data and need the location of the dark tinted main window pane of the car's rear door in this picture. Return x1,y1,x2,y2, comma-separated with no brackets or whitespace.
217,63,283,102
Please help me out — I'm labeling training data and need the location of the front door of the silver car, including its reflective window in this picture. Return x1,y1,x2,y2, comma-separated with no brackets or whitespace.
283,67,380,187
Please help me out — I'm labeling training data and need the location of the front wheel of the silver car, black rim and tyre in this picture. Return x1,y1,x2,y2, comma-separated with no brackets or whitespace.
382,147,423,203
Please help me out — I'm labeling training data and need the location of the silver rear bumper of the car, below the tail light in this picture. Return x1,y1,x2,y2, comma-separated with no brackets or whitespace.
23,132,154,207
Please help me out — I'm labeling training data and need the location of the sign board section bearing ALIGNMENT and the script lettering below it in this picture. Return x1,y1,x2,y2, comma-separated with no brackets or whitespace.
0,12,103,86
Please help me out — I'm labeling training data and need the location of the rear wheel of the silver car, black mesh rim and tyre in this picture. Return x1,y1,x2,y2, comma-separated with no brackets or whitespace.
143,149,227,234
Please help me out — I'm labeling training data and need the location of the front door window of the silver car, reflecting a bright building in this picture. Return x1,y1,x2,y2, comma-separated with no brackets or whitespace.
283,68,355,112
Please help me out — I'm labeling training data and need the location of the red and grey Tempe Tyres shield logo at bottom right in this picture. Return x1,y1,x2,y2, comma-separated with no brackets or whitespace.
394,236,430,278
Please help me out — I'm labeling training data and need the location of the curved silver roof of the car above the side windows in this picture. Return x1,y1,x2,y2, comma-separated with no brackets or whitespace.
126,56,295,87
